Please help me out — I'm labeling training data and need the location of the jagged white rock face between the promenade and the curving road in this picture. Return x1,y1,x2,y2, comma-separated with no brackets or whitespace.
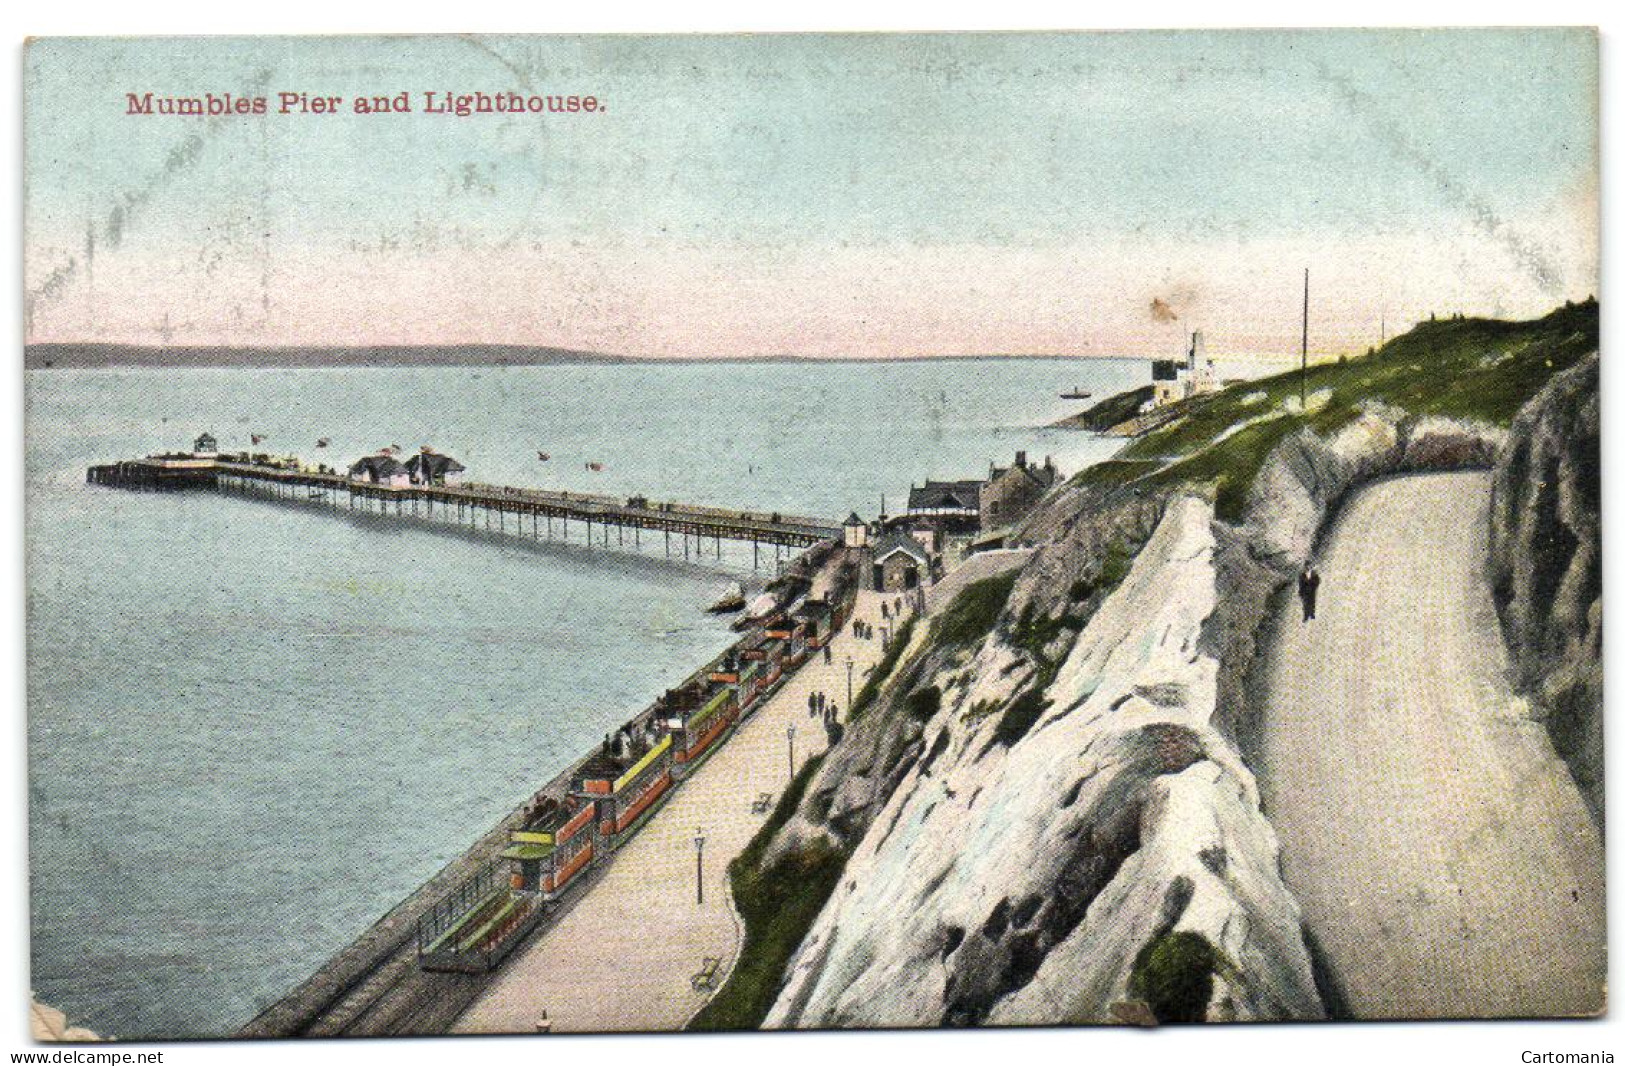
765,496,1323,1027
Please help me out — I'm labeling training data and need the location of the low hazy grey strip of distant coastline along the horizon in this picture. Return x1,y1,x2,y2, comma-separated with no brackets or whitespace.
23,343,1142,371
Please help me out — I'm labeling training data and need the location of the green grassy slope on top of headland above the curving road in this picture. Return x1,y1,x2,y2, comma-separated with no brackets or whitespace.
1077,299,1597,520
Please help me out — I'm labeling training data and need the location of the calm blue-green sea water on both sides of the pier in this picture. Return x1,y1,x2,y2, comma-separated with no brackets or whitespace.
26,361,1149,1038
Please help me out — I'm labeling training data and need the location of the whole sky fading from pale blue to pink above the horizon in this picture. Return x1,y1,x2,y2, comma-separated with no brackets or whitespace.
24,29,1596,354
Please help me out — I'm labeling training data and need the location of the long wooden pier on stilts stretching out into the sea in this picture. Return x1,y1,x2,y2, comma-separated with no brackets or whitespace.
86,457,840,562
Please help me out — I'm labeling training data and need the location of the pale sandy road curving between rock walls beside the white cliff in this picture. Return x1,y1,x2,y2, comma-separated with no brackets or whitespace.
1258,473,1607,1019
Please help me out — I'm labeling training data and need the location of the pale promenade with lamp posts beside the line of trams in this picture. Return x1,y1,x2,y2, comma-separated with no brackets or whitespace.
453,592,894,1034
